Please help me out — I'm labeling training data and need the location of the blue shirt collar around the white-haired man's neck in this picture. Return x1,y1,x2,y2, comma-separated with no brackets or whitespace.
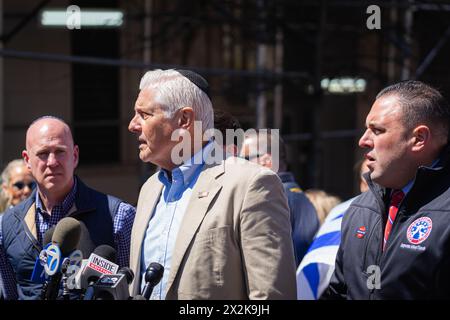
158,140,214,186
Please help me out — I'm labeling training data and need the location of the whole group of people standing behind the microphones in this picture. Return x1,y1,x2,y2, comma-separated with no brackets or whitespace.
0,70,450,300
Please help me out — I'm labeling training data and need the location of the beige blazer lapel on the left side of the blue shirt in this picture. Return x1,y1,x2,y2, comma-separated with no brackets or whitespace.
130,174,163,295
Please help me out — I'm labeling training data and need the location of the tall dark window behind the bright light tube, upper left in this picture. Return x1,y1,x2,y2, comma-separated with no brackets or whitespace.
71,1,120,165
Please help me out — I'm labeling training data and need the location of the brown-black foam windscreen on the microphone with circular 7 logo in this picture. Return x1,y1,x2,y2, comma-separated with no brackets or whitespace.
52,217,81,256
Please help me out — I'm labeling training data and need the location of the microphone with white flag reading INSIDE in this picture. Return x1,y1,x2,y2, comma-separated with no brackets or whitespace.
80,245,119,300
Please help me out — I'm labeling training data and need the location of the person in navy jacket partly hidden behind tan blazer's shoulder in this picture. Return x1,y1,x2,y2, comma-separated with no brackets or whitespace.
240,130,320,266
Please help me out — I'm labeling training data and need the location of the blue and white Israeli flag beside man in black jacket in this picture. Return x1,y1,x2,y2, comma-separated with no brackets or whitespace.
297,197,356,300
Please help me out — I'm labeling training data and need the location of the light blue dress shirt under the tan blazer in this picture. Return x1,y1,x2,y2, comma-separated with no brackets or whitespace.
141,142,214,300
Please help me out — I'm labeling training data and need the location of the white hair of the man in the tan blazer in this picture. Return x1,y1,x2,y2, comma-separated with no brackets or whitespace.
139,69,214,132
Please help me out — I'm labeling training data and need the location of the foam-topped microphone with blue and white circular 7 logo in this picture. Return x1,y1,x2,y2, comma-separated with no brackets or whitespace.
42,217,81,300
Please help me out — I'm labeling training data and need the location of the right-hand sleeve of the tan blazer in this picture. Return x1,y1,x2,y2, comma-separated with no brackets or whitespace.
240,170,297,299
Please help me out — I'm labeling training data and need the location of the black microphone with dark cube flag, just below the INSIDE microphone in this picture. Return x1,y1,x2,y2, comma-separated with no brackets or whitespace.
94,267,134,300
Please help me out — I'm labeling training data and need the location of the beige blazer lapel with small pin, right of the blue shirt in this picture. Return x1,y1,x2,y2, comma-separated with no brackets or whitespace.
167,162,224,292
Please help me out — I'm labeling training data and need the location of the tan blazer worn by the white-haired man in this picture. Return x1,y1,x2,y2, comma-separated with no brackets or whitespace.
130,157,296,299
